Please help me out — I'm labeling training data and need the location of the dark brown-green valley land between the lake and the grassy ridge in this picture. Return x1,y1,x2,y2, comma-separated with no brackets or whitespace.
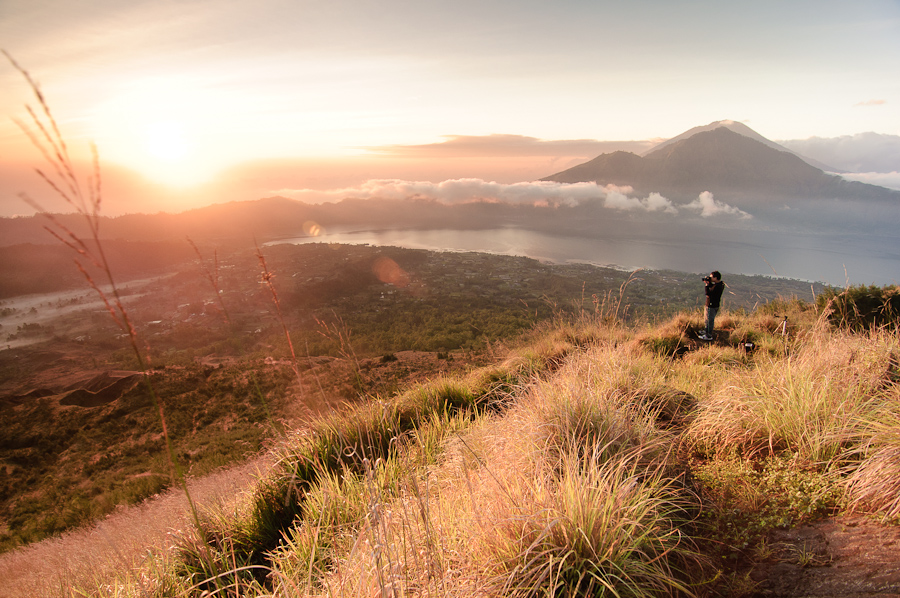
0,244,823,551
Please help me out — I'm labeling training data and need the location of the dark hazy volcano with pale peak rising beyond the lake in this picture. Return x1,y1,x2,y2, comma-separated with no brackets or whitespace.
542,121,900,203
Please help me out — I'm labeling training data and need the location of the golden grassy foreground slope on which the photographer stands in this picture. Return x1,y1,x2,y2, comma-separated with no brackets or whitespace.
1,291,900,598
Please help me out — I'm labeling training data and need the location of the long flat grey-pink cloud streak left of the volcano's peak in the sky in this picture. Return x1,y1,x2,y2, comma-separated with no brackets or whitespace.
365,134,654,158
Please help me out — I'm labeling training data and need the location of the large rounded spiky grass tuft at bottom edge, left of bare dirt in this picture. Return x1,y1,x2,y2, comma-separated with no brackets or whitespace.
486,446,705,596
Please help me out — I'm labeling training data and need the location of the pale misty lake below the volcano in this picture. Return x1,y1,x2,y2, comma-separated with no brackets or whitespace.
273,227,900,286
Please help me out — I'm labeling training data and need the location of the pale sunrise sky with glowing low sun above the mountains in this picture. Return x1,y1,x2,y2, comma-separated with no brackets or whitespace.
0,0,900,216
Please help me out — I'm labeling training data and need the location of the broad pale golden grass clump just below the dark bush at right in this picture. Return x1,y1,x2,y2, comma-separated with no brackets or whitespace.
688,332,896,463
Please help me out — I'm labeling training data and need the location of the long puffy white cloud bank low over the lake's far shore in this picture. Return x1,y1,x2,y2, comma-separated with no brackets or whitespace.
272,179,751,218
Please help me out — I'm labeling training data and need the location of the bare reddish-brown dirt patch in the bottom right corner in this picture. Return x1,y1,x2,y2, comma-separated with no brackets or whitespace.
751,516,900,598
